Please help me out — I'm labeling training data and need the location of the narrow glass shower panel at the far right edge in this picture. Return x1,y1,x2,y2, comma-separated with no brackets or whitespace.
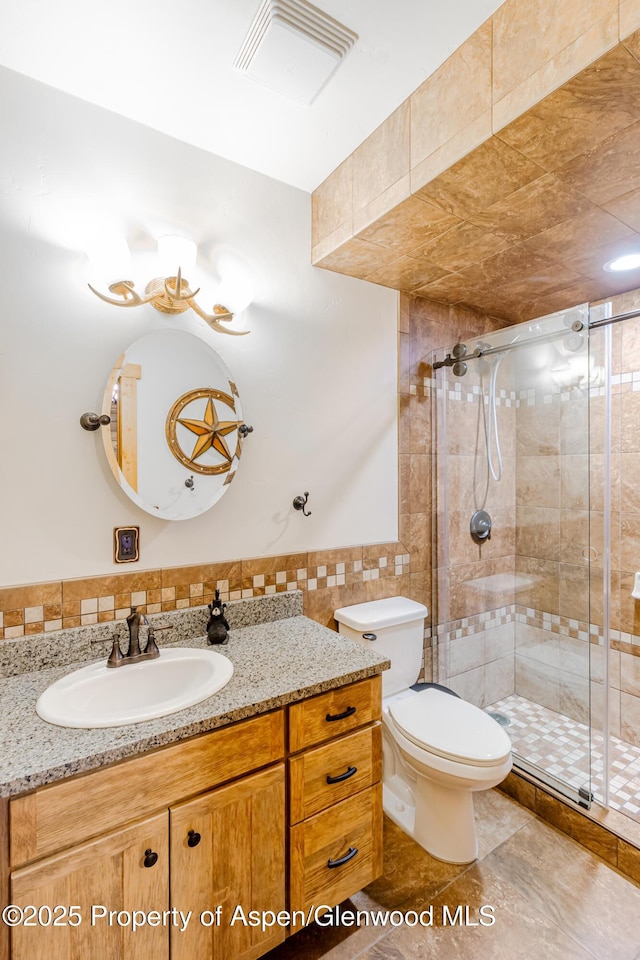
590,290,640,820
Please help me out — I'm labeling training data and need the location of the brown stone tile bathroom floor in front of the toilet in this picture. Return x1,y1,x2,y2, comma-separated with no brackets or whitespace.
267,790,640,960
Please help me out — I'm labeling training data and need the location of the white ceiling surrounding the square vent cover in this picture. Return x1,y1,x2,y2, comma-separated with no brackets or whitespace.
0,0,508,190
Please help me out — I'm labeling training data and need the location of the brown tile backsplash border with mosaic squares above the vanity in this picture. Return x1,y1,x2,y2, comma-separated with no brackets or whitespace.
0,543,411,640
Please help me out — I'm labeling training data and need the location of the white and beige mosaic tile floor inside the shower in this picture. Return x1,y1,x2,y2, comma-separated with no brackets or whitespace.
487,693,640,820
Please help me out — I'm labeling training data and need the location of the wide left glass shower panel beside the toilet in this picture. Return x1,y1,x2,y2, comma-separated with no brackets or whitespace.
433,308,592,804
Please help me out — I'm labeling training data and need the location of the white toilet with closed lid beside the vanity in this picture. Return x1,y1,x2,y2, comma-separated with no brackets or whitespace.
334,597,511,863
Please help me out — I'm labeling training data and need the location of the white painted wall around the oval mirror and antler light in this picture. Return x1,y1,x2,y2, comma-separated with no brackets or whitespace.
0,69,398,585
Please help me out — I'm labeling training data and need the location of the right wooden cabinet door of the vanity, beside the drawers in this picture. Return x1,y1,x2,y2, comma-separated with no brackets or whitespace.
169,764,285,960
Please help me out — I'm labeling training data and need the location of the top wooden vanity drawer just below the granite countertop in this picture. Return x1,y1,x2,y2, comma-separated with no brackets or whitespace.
289,676,382,753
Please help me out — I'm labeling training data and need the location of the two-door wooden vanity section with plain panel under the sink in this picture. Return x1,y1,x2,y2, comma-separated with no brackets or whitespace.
9,710,286,960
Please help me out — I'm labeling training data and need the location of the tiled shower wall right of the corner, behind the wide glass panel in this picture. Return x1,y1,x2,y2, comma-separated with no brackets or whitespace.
515,370,591,723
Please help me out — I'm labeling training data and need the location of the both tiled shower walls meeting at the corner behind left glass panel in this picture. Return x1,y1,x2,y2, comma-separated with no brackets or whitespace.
437,310,591,721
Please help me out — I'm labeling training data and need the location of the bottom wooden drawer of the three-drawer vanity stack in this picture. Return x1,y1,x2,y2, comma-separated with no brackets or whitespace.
289,783,382,910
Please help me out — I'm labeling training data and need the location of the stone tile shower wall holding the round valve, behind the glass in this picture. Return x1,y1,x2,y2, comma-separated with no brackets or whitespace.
431,344,516,706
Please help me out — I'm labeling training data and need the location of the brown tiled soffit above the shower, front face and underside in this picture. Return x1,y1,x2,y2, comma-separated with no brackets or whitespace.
312,0,640,322
